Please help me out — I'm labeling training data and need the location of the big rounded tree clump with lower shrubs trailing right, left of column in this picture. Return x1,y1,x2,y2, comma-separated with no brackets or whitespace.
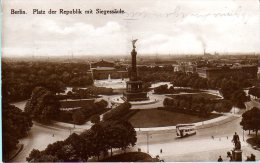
25,87,108,124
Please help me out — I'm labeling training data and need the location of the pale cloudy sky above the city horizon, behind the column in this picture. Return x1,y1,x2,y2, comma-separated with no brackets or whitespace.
2,0,260,57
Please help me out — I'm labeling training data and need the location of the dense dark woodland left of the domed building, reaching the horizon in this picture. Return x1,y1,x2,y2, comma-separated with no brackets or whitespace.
2,62,93,101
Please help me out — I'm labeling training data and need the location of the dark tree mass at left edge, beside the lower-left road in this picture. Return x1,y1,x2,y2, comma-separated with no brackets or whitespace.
2,102,33,161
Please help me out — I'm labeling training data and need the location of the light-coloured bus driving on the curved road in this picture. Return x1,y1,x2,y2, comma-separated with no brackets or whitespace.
176,124,196,137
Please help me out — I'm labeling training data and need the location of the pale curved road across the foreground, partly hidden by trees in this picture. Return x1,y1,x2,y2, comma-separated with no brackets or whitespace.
12,97,260,162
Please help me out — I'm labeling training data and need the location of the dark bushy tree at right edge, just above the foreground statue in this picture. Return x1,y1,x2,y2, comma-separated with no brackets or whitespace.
240,107,260,136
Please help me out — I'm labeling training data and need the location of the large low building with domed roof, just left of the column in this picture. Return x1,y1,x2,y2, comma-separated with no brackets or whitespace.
90,60,128,80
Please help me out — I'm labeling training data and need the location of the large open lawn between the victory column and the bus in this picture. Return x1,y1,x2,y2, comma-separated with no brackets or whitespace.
128,109,220,128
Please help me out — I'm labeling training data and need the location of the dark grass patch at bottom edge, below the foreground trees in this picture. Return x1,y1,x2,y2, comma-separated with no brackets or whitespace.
100,152,155,162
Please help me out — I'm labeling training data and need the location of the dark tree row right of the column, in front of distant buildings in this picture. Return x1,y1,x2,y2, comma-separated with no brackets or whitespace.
147,72,248,108
